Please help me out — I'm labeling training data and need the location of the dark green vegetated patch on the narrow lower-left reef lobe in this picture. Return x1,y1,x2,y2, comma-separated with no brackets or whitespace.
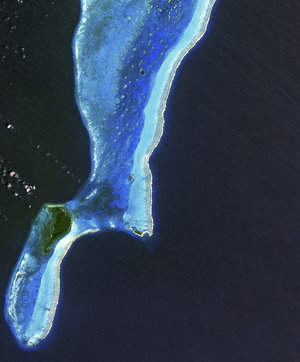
44,206,72,254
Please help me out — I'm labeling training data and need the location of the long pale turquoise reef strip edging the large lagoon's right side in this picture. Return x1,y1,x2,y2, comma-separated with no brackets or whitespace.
128,0,216,236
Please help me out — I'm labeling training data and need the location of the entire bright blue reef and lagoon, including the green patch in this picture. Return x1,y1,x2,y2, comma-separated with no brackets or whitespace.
5,0,214,349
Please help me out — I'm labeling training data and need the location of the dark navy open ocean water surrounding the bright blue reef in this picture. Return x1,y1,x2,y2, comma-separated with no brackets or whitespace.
0,0,300,362
